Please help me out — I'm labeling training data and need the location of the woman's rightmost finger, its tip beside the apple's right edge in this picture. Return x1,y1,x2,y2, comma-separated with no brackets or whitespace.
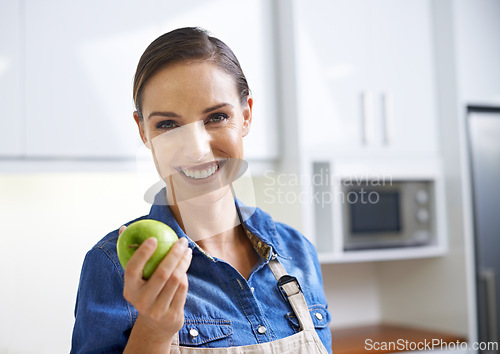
145,237,188,296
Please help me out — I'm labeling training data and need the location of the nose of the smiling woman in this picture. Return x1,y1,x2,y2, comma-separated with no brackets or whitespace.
180,121,212,163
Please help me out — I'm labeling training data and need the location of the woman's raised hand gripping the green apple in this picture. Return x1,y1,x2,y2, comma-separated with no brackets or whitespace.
119,226,192,348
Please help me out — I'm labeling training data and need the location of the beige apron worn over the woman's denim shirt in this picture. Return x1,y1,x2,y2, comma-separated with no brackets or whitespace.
170,257,328,354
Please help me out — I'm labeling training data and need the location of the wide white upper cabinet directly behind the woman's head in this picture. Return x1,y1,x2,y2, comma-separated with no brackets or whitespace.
23,0,279,160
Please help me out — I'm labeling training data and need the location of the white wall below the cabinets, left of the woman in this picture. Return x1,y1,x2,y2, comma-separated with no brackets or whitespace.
0,174,149,354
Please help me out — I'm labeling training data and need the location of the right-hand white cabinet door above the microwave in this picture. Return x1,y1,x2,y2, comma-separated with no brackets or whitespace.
365,0,438,155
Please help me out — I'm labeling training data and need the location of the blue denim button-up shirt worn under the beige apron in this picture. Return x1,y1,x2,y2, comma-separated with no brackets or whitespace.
71,190,331,353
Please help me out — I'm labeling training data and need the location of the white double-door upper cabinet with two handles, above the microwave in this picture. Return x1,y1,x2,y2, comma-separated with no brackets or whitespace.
293,0,438,157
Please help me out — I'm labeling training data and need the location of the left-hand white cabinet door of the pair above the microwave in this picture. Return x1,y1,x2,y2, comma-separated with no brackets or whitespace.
294,0,370,151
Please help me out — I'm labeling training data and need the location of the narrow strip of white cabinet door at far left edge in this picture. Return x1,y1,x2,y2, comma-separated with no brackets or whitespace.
0,0,24,157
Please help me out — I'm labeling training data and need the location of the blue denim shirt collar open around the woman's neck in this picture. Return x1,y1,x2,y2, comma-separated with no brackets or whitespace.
148,188,290,259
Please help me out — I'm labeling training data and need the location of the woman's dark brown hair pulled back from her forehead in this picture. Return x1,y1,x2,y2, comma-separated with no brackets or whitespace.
133,27,250,120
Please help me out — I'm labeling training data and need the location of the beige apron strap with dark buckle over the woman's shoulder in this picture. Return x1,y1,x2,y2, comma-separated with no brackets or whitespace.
269,254,314,331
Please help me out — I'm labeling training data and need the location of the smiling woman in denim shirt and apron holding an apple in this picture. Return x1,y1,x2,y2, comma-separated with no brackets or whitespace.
72,28,331,353
